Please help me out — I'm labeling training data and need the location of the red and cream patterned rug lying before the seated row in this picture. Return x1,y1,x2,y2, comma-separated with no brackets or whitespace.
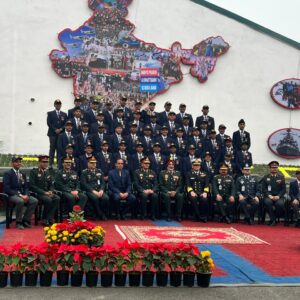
115,225,268,244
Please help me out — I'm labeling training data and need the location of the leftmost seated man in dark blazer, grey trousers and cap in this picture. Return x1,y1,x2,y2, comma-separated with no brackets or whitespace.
3,157,38,229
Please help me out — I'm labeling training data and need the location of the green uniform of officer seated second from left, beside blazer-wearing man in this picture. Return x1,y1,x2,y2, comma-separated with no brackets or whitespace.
29,168,60,223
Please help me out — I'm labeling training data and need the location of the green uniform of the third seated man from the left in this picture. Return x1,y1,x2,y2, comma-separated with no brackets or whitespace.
55,169,87,212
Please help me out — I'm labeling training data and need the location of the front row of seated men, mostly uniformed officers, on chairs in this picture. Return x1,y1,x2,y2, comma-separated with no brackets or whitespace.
3,156,300,229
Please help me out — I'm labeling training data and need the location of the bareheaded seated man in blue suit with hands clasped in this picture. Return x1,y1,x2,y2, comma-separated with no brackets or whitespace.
108,158,136,220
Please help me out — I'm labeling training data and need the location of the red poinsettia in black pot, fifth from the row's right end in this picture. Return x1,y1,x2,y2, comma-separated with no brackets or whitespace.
141,244,154,287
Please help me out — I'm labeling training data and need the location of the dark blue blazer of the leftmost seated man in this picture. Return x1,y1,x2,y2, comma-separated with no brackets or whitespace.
3,169,29,196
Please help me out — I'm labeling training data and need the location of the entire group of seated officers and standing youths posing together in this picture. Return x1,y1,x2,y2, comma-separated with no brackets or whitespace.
3,96,300,229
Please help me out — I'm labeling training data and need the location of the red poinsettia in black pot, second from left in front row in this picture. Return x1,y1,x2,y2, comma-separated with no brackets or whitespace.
6,243,27,287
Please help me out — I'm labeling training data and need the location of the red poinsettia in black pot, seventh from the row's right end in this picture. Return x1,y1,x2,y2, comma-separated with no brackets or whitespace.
114,244,129,286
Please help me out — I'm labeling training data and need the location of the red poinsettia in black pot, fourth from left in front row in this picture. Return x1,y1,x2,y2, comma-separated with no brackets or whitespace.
37,243,58,287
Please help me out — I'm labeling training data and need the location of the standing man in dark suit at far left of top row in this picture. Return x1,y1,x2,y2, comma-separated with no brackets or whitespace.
47,99,67,168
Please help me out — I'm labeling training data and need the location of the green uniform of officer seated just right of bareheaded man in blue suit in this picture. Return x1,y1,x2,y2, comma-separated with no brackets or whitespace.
133,168,158,219
